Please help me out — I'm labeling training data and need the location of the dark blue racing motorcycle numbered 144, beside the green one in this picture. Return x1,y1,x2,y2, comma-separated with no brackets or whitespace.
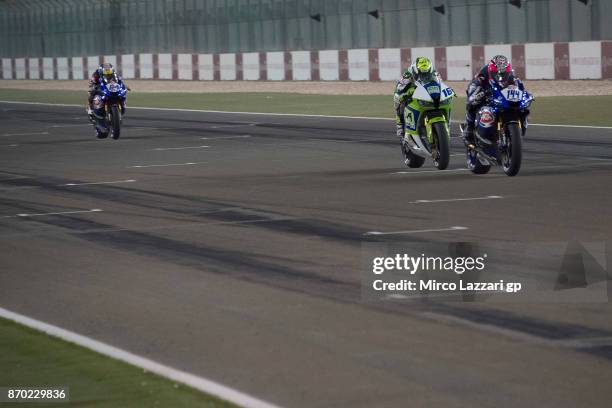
461,81,534,176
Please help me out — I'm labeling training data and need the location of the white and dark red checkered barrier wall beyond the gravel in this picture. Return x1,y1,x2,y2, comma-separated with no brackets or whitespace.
0,41,612,81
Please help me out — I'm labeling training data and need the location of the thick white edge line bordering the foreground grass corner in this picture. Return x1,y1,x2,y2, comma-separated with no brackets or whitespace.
0,307,278,408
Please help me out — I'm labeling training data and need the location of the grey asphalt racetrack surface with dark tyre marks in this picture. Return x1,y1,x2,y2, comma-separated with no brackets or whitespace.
0,103,612,407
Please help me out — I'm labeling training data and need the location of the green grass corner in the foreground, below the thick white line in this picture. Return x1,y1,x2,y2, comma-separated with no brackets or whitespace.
0,318,235,408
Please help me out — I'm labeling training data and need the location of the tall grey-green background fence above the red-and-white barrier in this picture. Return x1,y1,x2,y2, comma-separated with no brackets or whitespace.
0,0,612,57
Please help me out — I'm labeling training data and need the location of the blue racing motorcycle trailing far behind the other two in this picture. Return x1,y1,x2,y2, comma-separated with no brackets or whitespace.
89,79,128,139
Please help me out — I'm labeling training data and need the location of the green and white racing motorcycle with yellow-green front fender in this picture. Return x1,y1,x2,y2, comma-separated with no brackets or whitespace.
402,79,456,170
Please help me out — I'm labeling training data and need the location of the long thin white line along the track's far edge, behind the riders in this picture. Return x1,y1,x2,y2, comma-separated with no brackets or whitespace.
0,100,612,130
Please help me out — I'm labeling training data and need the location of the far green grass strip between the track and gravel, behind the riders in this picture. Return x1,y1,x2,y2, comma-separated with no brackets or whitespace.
0,89,612,126
